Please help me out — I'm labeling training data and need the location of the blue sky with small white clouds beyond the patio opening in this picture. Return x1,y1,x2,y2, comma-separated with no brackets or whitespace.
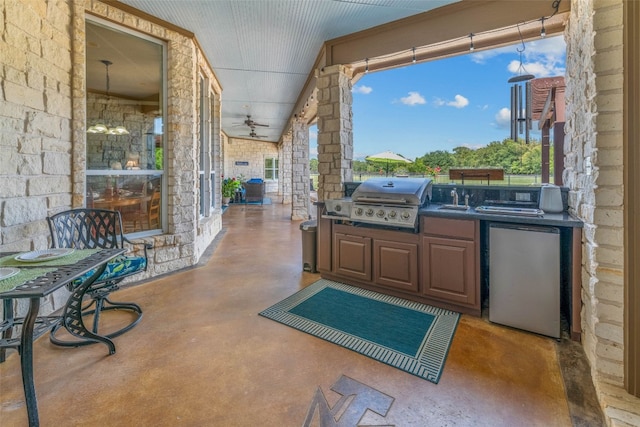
310,36,566,160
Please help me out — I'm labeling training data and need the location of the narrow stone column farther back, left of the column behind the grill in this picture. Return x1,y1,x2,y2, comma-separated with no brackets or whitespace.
291,122,310,220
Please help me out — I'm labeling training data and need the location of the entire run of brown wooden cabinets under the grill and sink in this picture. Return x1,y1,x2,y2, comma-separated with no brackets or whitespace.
318,217,480,315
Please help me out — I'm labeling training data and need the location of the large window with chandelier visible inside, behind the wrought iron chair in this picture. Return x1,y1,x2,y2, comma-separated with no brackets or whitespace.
86,17,166,234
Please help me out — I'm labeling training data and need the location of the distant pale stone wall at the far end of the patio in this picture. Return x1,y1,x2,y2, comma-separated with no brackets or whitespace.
224,138,279,194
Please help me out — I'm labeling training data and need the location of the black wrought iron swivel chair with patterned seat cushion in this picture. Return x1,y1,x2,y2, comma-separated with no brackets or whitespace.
47,209,152,347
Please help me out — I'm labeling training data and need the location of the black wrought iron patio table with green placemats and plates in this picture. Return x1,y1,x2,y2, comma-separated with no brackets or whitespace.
0,249,126,426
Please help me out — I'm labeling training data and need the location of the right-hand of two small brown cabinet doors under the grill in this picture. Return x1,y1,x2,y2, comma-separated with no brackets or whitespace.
373,239,418,292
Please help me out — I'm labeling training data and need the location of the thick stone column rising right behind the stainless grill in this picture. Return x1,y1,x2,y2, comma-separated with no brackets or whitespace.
317,65,353,201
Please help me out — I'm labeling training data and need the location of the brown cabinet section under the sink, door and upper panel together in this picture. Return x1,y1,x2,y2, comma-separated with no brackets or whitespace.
420,218,481,315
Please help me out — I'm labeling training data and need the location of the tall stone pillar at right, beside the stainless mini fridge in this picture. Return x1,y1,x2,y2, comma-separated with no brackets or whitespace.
563,0,640,426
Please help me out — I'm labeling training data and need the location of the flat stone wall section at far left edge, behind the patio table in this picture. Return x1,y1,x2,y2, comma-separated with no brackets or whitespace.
0,1,73,313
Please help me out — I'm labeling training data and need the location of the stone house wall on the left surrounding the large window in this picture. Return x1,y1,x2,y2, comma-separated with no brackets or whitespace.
0,0,222,313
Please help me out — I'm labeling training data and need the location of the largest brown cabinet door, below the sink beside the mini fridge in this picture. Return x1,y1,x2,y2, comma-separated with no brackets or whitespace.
422,236,478,305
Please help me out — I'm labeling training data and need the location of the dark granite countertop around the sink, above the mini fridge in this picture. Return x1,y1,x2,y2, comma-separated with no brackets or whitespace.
418,203,583,228
